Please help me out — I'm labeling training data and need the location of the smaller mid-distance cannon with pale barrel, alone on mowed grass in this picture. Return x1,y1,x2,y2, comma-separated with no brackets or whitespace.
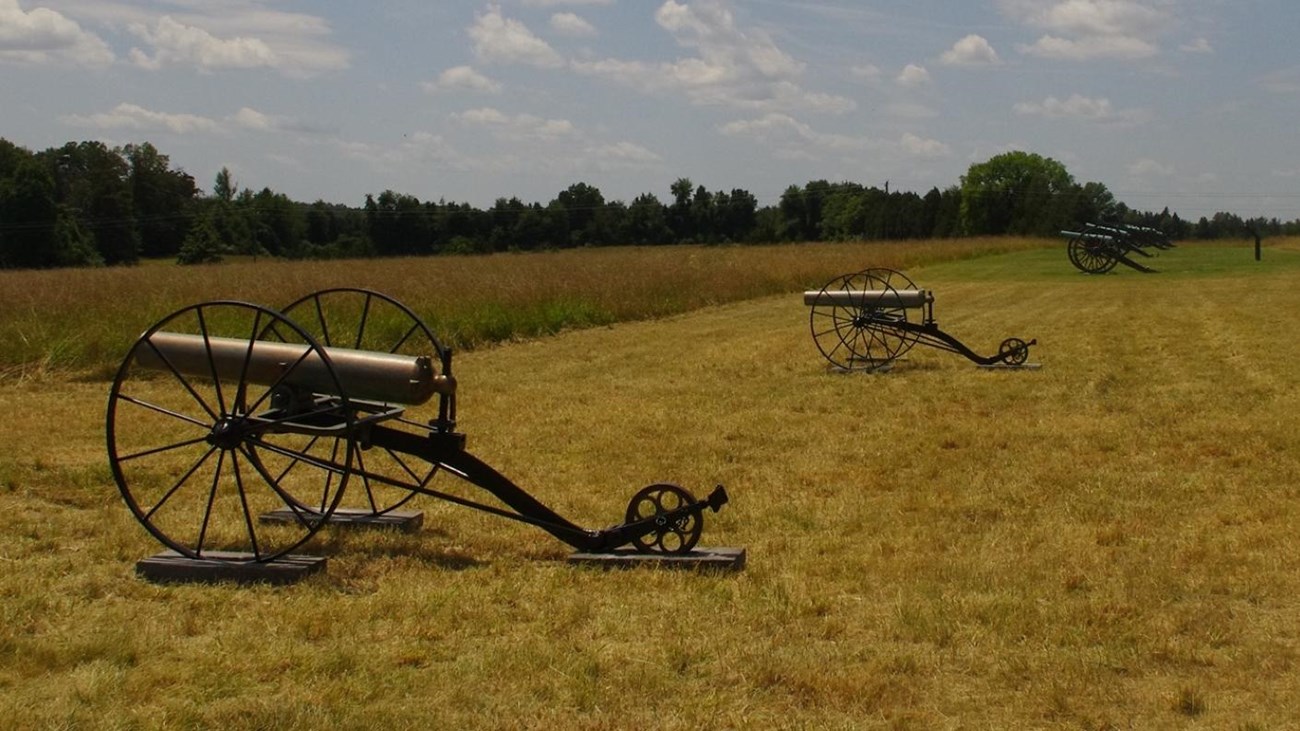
803,268,1037,371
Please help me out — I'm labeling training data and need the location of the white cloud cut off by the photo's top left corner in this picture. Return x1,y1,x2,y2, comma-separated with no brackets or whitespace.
0,0,114,66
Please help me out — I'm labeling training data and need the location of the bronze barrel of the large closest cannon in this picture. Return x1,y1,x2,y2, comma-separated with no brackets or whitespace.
134,332,456,405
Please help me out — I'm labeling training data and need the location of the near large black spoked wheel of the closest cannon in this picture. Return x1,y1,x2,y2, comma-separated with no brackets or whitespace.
105,302,355,562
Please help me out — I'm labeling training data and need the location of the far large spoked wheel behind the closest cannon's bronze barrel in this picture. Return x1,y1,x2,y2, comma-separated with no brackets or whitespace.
268,287,454,516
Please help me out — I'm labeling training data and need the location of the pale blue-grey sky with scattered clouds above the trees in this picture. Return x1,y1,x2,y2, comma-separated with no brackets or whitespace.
0,0,1300,221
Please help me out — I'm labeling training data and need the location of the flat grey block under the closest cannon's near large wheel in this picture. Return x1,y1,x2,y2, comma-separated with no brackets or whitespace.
135,550,325,584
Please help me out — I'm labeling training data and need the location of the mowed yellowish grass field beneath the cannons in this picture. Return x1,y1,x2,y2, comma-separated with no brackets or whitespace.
0,236,1300,730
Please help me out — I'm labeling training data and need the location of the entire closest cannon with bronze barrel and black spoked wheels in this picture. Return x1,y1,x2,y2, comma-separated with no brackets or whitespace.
105,287,742,574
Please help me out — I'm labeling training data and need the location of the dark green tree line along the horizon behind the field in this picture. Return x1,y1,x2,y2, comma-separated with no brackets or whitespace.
0,138,1300,268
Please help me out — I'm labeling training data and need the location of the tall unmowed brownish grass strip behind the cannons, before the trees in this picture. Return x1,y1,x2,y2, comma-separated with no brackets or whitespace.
0,238,1045,379
